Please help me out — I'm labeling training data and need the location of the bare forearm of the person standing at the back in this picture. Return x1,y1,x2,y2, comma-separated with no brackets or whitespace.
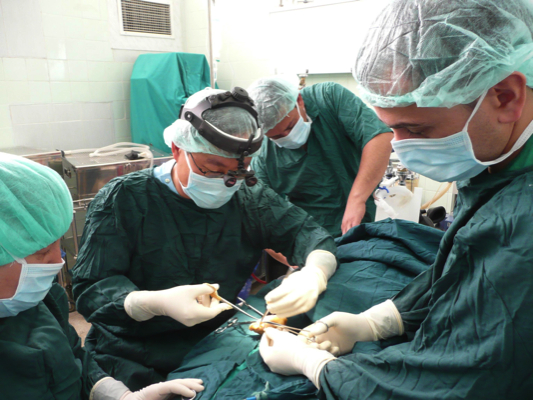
347,132,393,207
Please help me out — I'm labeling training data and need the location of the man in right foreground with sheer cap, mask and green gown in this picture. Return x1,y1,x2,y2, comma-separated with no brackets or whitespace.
261,0,533,399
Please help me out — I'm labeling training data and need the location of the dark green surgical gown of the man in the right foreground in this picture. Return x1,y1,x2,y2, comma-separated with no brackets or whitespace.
320,162,533,400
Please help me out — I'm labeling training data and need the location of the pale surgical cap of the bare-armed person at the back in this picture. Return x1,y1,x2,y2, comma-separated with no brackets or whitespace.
248,77,298,133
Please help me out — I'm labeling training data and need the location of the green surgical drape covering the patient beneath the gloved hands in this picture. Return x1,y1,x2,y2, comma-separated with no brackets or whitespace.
167,219,442,400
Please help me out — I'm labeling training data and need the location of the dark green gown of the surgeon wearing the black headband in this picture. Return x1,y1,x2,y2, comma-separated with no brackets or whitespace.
73,170,336,390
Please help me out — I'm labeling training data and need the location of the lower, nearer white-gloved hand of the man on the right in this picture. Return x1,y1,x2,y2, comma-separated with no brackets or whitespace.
259,328,335,388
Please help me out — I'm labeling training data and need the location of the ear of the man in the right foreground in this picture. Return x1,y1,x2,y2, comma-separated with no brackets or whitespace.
489,72,527,124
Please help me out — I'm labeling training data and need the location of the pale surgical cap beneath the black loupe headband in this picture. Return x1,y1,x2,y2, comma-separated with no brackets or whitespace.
164,88,258,158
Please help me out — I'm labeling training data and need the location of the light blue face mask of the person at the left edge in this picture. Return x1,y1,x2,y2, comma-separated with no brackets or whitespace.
0,258,65,318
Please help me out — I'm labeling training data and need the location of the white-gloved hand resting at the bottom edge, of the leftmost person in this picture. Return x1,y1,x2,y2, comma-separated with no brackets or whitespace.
89,378,204,400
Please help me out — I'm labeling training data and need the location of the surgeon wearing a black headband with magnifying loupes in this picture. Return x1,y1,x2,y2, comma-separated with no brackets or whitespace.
73,88,336,388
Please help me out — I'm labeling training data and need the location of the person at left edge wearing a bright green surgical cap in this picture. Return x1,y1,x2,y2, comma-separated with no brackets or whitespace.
0,153,203,400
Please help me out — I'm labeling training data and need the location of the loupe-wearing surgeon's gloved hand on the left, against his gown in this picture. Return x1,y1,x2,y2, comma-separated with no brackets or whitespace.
124,284,231,326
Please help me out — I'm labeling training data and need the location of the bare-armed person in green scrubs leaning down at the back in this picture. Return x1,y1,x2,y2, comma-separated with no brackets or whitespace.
248,77,392,237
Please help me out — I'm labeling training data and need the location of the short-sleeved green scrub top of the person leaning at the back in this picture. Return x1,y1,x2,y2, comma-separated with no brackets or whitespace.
251,82,391,237
